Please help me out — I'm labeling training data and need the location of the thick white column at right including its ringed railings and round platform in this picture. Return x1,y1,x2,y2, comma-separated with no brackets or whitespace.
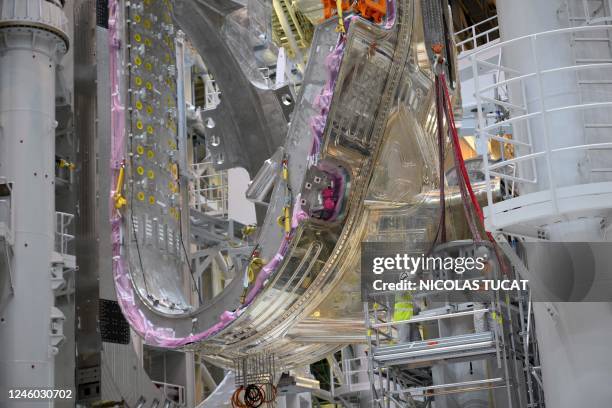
478,0,612,408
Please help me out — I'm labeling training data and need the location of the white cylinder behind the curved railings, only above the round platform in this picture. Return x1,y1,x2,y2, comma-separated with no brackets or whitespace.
497,0,588,194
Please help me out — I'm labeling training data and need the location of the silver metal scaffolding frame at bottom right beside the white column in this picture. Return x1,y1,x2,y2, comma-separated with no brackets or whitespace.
364,241,544,408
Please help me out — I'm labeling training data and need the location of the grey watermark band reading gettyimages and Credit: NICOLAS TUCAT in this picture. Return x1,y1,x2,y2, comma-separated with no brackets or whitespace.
361,241,612,302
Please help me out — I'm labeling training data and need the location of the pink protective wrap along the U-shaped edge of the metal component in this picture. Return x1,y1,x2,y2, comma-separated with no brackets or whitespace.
108,0,345,348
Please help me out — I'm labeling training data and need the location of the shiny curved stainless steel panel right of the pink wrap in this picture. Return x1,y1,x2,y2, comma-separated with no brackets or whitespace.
113,0,498,366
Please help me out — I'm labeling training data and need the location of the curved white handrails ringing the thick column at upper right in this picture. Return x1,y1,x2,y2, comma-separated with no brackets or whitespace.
474,25,612,229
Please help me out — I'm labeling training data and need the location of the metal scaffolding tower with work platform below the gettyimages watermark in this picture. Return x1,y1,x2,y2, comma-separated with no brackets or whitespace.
364,241,543,408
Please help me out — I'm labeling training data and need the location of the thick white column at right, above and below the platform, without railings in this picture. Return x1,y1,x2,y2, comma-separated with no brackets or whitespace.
497,0,612,408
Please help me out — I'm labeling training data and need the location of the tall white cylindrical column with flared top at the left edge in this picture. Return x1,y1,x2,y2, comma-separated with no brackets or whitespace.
0,0,68,407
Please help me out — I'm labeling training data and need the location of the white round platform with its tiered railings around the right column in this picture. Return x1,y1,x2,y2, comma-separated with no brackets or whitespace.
469,26,612,234
